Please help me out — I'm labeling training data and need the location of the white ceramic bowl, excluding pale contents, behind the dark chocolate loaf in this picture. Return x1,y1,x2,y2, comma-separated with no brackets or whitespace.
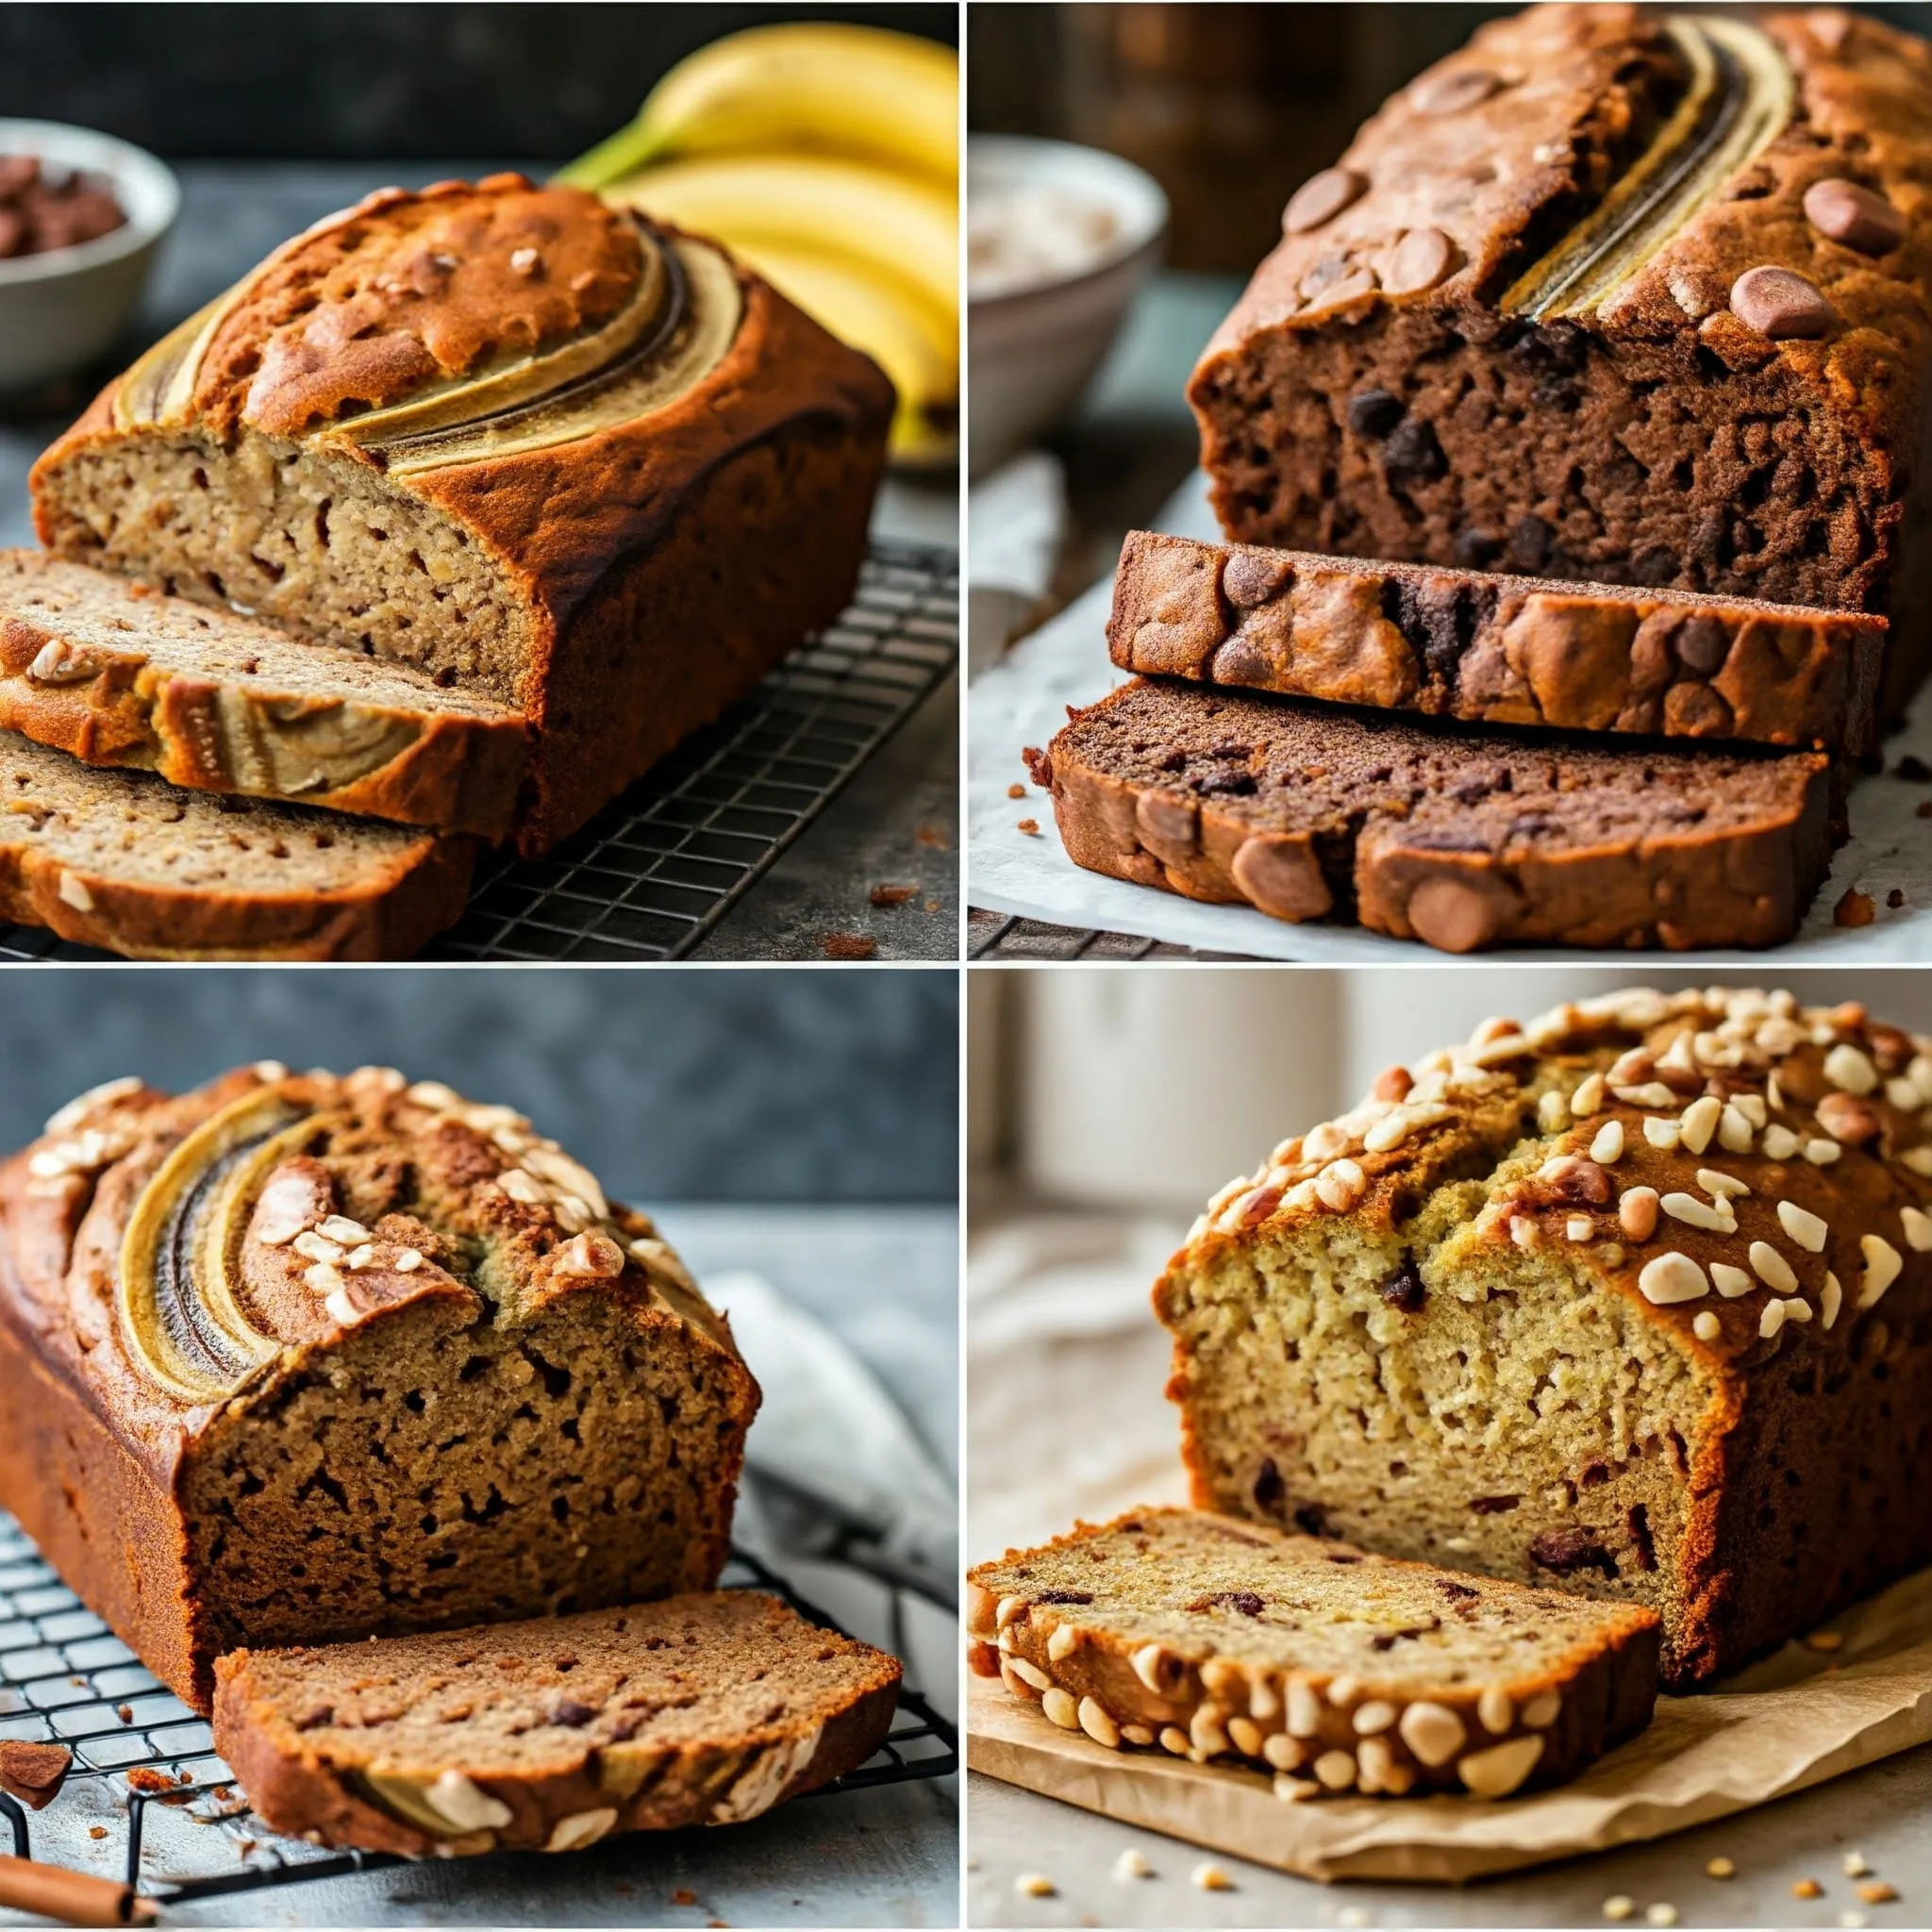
966,133,1167,475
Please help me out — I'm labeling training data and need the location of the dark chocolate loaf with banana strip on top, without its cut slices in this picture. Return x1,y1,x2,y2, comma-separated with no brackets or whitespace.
1191,6,1932,713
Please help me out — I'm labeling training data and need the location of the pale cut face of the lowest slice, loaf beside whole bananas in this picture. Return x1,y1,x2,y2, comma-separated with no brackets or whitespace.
0,732,429,898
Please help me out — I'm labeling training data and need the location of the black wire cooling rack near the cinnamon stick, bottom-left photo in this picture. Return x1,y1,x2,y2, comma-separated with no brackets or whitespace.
0,1515,960,1907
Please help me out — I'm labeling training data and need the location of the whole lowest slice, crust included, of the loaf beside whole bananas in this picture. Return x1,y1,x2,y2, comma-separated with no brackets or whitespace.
0,730,477,960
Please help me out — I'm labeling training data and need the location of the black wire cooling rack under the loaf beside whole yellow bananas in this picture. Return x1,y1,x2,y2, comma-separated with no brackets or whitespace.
0,542,958,960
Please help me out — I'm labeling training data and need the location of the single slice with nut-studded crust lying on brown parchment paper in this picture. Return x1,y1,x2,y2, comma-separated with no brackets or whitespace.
966,1508,1657,1799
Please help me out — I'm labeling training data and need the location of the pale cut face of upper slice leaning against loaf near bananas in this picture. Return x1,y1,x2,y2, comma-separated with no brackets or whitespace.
0,551,500,717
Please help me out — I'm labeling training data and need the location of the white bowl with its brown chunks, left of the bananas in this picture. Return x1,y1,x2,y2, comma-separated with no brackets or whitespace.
0,120,182,394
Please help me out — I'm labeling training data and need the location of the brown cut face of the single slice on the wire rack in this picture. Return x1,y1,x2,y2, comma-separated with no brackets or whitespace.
224,1591,898,1775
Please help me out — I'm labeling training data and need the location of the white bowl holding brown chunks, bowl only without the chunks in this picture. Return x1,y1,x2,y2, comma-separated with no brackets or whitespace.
0,120,182,392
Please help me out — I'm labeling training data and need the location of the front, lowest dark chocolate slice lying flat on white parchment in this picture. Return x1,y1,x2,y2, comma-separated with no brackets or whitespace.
1025,678,1836,953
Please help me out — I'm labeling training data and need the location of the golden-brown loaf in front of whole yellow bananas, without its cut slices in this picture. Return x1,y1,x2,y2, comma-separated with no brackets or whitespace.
33,174,892,852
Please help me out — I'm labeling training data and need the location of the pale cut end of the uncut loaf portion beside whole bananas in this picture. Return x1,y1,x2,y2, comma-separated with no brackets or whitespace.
37,429,531,706
